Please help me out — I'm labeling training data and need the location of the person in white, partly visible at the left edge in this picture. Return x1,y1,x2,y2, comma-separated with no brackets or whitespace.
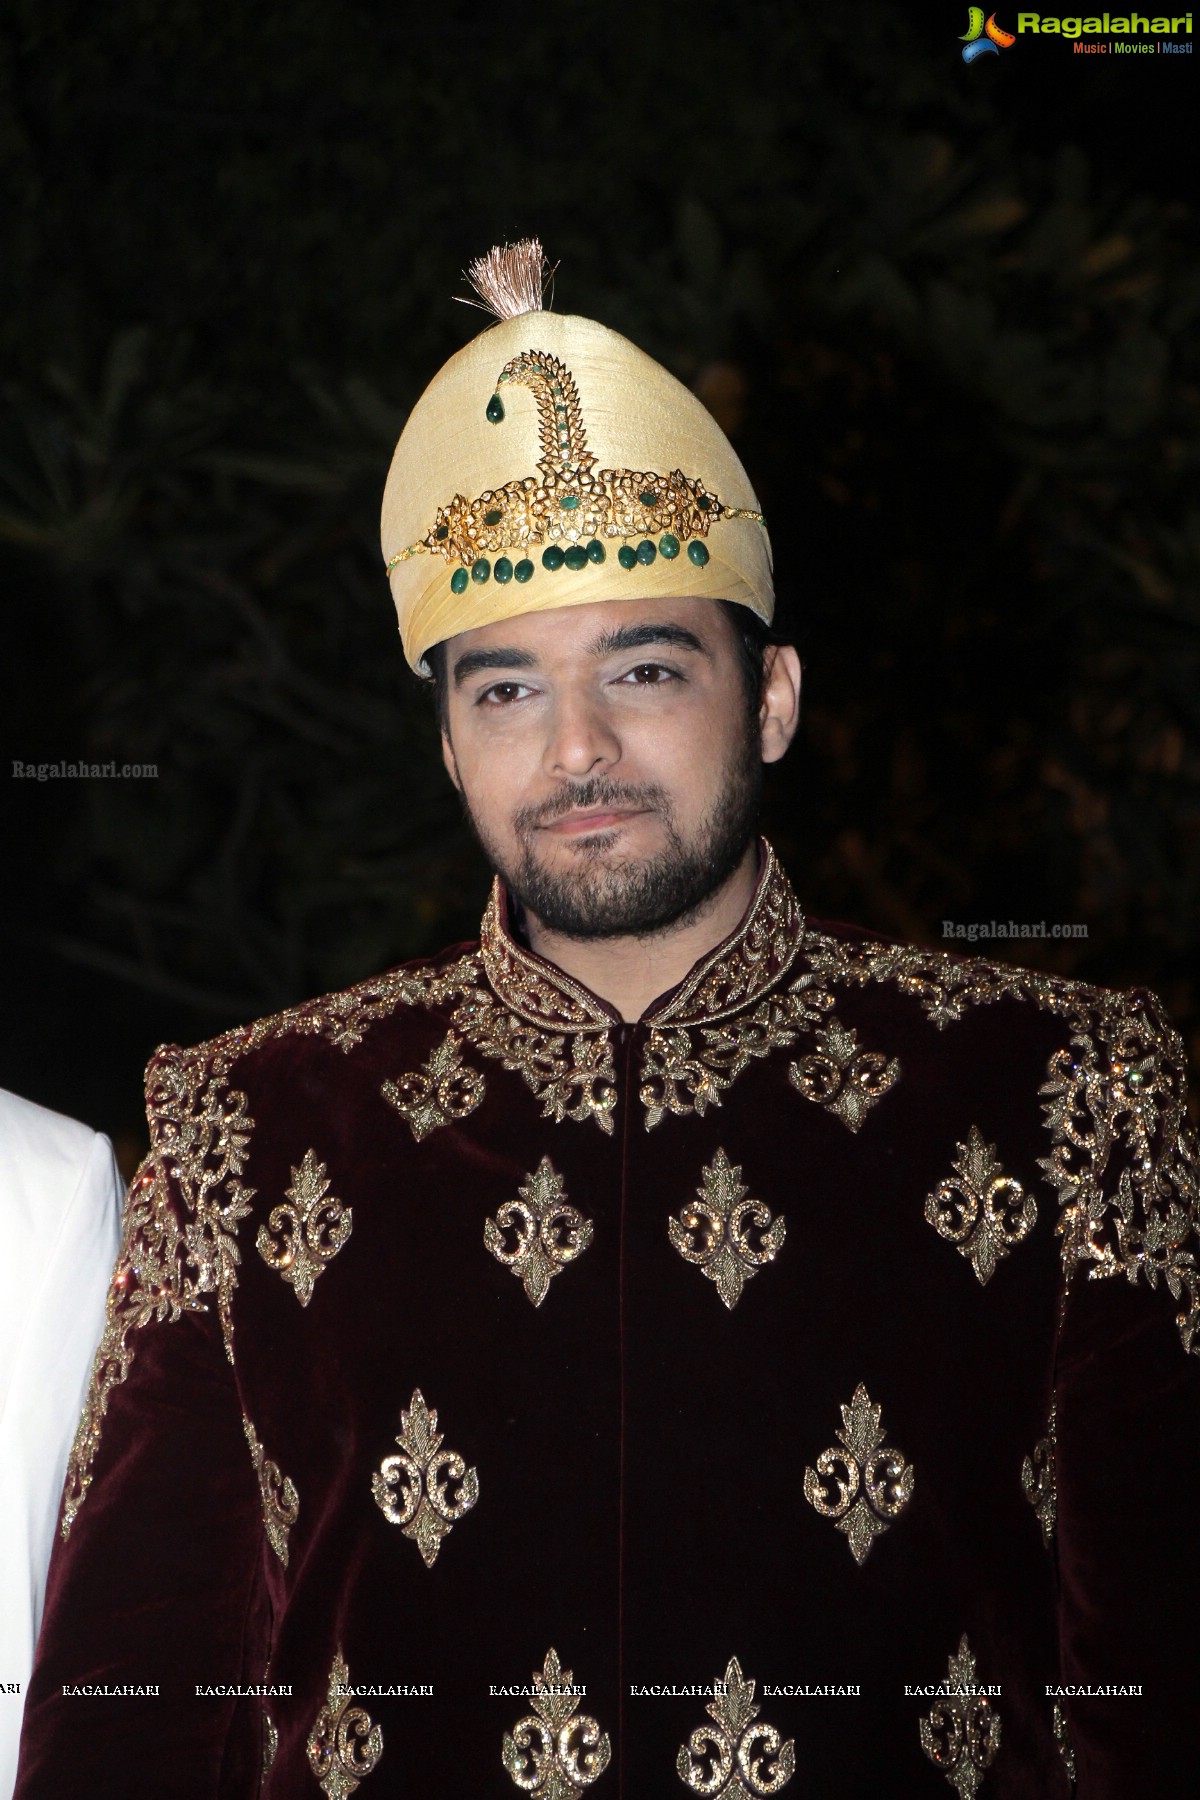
0,1091,124,1795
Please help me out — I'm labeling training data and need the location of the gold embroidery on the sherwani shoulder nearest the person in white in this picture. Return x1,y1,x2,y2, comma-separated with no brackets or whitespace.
59,1049,254,1537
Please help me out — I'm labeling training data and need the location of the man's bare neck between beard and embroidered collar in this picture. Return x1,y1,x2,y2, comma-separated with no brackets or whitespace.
525,841,759,1021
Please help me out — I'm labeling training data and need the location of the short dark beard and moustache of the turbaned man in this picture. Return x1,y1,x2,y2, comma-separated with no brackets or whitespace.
462,720,763,940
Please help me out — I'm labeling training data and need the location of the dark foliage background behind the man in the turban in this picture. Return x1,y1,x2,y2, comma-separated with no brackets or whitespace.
0,0,1200,1173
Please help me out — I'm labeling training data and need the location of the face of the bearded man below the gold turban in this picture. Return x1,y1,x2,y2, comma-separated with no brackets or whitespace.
443,599,780,938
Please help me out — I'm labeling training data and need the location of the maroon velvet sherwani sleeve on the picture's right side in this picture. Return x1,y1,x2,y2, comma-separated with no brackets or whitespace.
1054,997,1200,1800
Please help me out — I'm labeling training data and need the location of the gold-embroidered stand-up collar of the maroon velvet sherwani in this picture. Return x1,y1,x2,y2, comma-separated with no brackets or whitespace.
480,841,804,1033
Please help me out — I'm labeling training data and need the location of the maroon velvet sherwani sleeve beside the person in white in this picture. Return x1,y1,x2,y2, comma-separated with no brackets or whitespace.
16,1053,270,1800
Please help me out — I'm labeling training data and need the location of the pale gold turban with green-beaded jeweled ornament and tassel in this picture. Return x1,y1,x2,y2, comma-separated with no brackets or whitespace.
381,243,774,673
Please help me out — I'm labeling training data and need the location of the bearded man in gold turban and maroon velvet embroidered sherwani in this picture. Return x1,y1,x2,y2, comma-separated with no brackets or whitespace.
18,247,1200,1800
